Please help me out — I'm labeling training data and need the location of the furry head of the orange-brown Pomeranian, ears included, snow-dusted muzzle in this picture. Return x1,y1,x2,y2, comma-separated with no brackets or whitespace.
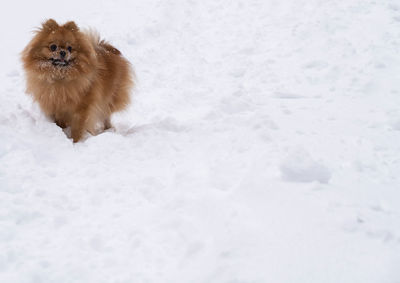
23,19,95,79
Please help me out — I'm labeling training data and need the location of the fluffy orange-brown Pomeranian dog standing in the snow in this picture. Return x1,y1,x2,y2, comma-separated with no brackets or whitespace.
22,19,134,142
